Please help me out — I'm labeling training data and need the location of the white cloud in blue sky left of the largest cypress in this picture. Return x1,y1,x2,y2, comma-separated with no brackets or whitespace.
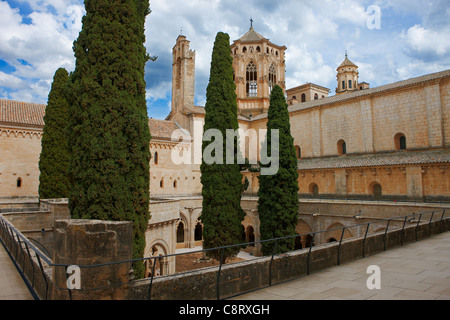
0,0,84,103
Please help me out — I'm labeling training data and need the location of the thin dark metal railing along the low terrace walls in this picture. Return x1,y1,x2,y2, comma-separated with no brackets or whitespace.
0,209,450,300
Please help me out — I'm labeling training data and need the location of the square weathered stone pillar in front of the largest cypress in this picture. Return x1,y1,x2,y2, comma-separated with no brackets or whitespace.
53,220,133,300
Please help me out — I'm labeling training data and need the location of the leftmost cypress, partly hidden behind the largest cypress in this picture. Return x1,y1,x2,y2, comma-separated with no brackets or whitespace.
39,68,70,199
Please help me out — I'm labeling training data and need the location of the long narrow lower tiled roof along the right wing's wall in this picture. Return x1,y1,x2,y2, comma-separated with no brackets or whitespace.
298,150,450,170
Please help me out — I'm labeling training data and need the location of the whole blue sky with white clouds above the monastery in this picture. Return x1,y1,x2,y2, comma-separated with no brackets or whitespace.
0,0,450,119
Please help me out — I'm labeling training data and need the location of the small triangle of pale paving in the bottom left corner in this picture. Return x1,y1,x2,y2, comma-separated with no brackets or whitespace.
0,243,33,300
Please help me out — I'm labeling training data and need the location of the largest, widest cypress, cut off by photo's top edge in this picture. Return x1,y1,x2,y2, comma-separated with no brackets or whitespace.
69,0,151,277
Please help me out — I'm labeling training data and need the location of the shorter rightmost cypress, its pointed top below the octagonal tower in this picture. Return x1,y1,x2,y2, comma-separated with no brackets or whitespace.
258,85,299,254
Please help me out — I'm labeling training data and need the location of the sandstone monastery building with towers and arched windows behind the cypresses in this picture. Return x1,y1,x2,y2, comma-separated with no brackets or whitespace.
0,27,450,273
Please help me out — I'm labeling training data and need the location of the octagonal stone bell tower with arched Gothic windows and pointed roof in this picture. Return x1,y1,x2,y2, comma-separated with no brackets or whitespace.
231,20,287,118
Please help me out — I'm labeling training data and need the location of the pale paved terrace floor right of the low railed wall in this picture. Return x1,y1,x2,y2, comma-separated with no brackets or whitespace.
233,232,450,300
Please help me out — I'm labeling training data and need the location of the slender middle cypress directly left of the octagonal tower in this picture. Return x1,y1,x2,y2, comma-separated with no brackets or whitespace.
200,32,245,261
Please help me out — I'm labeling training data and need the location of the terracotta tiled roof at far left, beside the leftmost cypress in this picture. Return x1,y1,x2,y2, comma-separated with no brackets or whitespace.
0,99,46,127
